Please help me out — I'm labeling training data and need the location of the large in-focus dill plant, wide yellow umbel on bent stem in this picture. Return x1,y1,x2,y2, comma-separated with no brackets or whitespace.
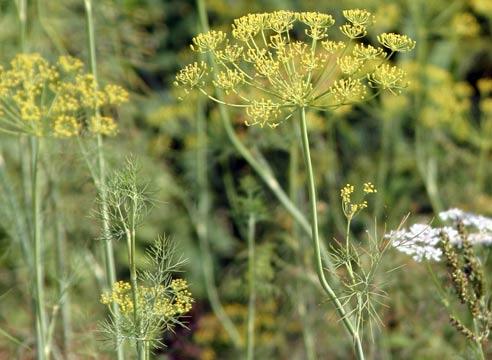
174,9,415,359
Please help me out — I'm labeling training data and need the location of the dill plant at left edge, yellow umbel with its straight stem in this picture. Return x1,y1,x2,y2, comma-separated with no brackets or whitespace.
0,53,126,358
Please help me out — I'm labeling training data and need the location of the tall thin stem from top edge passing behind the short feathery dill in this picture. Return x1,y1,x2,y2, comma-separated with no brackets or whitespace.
84,0,125,360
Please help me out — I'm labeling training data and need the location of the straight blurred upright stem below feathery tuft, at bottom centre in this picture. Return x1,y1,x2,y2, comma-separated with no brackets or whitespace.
246,214,256,360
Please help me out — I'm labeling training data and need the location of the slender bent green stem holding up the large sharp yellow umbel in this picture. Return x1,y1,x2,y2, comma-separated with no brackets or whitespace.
300,107,364,360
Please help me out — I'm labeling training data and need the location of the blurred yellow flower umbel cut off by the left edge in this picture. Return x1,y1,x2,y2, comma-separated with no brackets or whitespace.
0,53,128,138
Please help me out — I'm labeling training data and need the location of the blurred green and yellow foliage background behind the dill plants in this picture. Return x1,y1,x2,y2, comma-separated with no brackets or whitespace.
0,0,492,359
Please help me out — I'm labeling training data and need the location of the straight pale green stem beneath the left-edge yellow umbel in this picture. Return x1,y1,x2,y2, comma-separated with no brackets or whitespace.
30,136,49,360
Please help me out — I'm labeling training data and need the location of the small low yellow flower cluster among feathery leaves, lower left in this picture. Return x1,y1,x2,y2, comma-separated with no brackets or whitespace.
101,279,194,319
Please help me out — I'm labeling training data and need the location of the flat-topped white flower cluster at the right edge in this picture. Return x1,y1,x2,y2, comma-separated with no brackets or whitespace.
385,209,492,262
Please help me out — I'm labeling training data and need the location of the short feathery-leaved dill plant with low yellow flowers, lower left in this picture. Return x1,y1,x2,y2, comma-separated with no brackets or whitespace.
98,159,193,359
